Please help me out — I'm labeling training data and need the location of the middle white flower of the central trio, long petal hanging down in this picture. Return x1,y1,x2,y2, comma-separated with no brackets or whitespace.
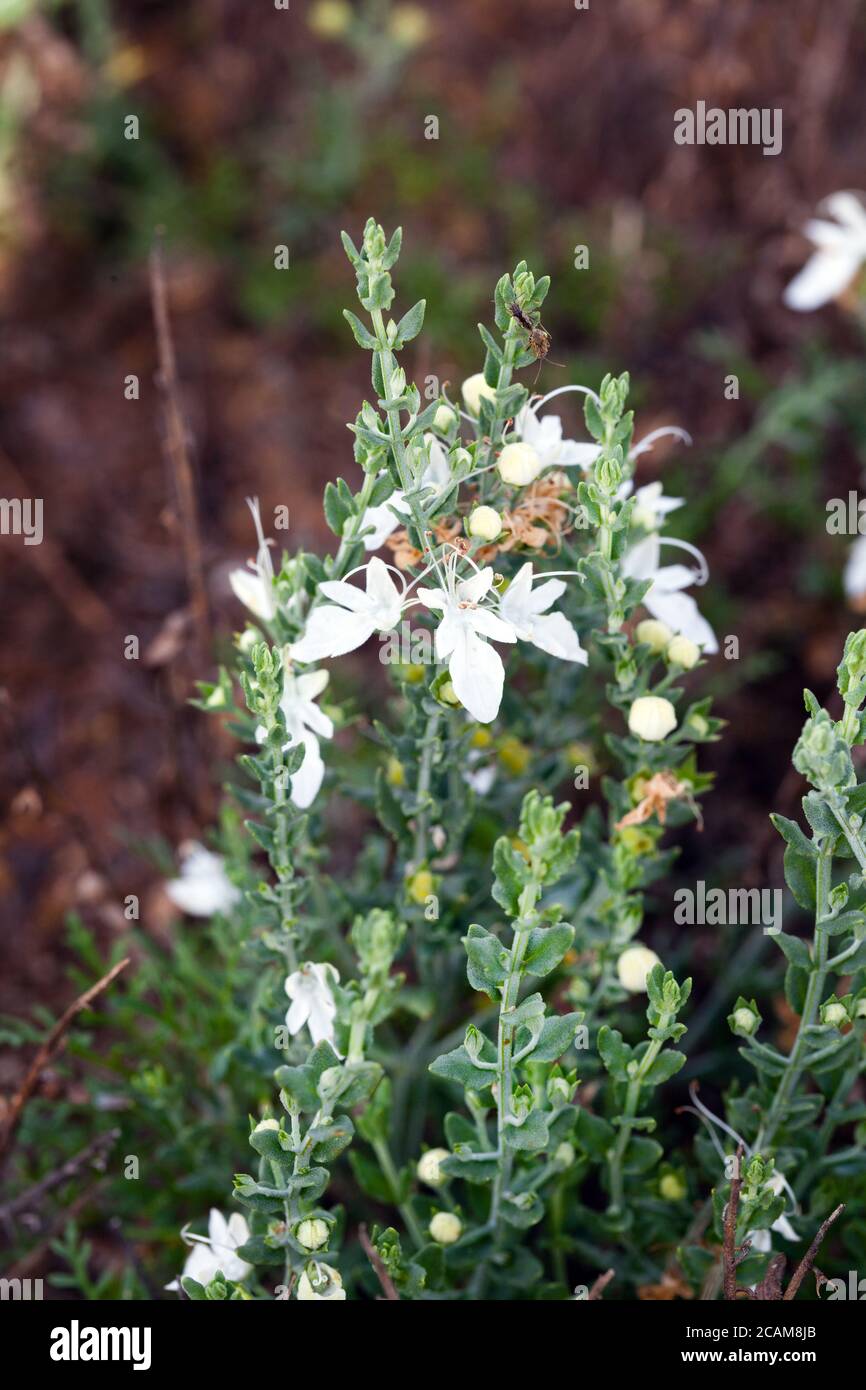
418,550,517,724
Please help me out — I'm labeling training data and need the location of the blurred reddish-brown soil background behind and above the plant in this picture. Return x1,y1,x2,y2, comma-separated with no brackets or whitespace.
0,0,866,1012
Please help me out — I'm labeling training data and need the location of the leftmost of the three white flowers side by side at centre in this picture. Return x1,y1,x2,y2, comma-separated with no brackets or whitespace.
289,556,403,662
